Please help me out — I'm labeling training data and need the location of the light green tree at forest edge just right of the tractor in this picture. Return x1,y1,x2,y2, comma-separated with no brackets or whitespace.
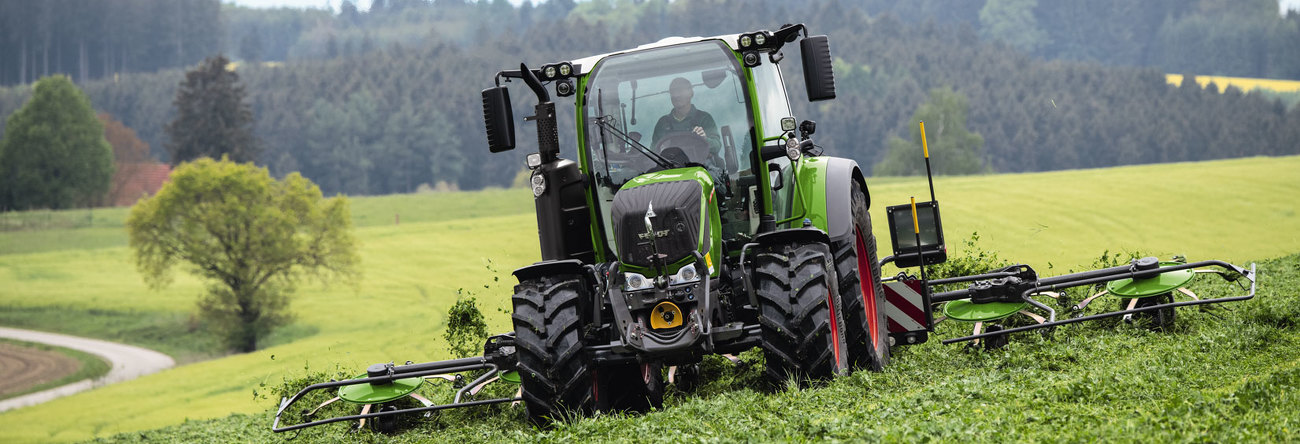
875,87,988,175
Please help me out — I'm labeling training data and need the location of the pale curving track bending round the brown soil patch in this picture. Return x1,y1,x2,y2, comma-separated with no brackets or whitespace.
0,327,176,412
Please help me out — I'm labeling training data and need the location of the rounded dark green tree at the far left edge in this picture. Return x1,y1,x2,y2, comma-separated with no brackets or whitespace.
0,75,113,209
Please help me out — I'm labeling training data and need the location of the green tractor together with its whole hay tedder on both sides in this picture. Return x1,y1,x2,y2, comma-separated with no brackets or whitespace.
273,25,1255,432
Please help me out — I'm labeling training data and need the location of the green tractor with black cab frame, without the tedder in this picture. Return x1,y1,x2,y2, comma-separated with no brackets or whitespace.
482,25,889,421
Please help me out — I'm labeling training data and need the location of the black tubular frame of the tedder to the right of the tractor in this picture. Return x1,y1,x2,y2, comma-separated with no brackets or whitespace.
932,261,1256,344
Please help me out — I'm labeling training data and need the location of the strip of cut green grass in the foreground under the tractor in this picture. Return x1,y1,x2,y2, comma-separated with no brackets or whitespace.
86,254,1300,443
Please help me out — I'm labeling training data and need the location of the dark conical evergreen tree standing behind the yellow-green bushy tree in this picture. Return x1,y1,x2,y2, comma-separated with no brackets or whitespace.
166,56,261,165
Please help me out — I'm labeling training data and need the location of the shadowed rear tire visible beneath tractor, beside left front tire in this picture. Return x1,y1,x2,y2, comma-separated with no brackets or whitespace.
595,364,663,413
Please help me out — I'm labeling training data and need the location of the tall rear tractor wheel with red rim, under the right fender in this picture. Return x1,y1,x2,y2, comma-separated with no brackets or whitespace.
831,180,889,371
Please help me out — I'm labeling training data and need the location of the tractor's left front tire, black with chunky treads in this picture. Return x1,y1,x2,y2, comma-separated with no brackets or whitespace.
511,275,594,425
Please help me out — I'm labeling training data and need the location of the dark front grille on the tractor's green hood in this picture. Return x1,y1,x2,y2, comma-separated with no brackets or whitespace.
611,180,707,266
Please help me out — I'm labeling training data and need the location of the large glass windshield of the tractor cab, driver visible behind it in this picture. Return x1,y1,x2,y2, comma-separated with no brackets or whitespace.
582,40,757,257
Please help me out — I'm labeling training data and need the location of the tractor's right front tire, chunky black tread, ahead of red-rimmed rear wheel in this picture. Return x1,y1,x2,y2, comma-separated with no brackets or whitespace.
753,238,848,387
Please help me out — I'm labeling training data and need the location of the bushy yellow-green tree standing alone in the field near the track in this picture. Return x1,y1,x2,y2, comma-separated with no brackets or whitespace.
126,158,360,352
